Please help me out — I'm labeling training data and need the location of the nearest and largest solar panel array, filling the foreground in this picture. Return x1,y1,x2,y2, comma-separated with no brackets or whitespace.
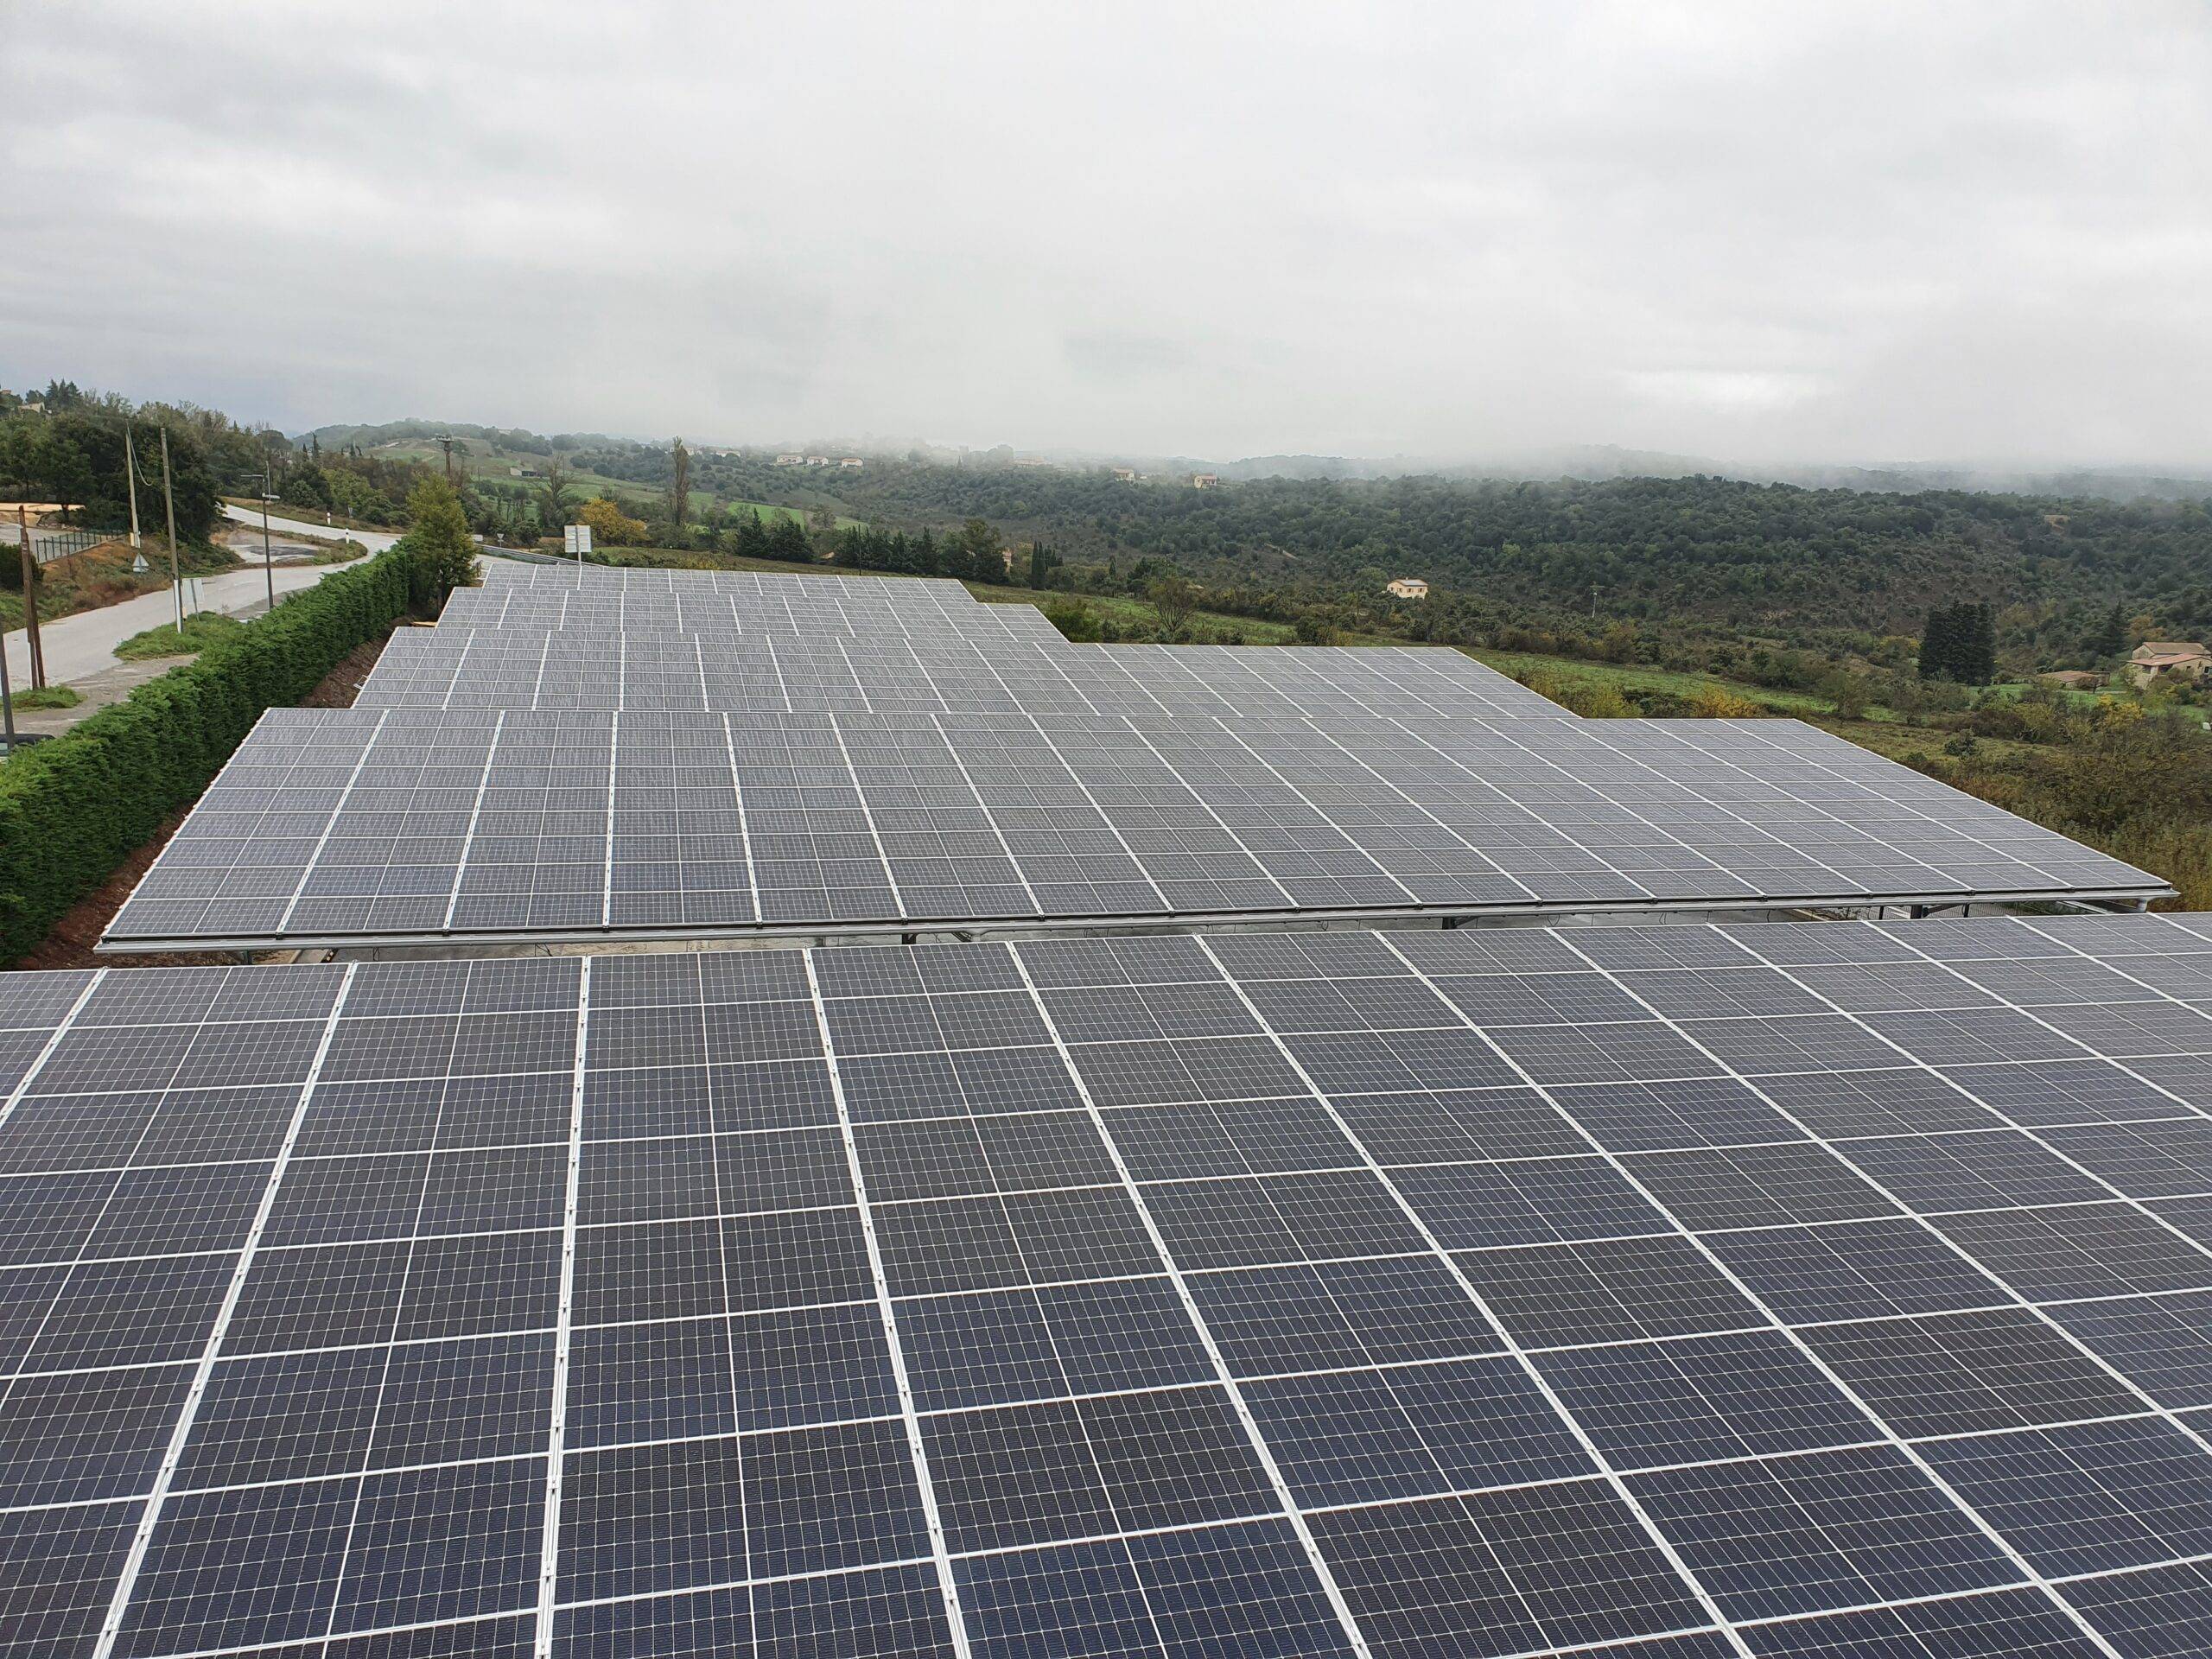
13,918,2212,1659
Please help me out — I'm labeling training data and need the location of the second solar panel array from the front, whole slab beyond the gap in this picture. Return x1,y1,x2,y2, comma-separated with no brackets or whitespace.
104,708,2161,949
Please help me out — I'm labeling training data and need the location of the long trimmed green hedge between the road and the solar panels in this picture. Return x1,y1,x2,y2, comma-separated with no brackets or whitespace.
0,549,407,963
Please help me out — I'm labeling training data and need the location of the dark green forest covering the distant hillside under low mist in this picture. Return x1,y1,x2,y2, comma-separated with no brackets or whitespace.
577,445,2212,666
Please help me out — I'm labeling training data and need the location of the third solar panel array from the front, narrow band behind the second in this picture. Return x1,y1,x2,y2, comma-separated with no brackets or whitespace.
354,628,1573,719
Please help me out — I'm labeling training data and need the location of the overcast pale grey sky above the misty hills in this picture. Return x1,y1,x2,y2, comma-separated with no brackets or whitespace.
0,0,2212,465
